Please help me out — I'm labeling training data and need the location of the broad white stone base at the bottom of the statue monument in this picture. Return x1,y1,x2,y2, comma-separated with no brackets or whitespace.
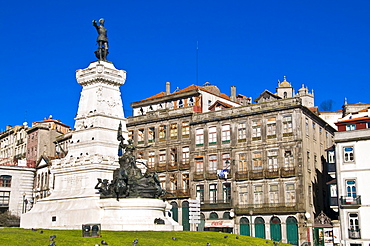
21,197,183,231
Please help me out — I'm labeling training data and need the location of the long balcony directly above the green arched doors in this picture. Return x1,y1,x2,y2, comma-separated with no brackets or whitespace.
235,203,299,214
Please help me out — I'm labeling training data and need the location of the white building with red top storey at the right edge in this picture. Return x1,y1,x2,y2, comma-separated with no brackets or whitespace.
335,110,370,246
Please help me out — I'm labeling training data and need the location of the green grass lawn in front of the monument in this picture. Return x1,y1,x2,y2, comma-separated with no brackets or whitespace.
0,228,294,246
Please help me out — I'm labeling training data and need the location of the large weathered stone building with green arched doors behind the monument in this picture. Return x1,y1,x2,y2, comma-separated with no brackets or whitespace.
127,78,335,244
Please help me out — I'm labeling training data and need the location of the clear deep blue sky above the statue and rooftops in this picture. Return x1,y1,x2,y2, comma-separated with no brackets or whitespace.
0,0,370,130
